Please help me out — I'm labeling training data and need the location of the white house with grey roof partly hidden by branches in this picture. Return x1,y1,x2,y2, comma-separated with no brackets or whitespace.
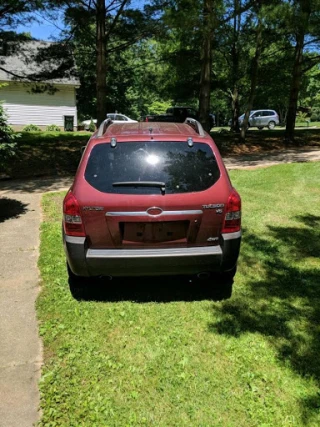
0,41,79,130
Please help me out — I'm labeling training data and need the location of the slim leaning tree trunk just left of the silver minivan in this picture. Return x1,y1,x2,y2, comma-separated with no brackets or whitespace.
240,12,262,142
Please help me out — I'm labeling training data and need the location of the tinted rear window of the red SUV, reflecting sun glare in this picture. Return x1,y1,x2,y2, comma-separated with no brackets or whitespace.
85,141,220,194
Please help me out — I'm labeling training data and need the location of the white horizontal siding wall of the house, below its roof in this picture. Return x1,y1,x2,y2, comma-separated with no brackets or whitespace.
0,83,77,127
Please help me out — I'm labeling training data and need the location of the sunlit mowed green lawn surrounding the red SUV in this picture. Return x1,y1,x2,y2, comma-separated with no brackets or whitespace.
37,163,320,427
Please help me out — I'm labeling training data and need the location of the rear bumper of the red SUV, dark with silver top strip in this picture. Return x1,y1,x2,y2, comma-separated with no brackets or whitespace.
63,232,241,277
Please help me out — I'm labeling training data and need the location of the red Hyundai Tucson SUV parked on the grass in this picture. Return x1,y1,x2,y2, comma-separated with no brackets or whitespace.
63,118,241,295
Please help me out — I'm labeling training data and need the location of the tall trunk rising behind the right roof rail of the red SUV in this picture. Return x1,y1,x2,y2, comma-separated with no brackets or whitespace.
199,0,214,132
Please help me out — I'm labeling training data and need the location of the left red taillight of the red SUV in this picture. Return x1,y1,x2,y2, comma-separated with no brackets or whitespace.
63,191,86,237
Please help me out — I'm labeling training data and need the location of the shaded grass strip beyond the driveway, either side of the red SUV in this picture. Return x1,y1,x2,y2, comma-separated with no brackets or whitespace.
0,127,320,179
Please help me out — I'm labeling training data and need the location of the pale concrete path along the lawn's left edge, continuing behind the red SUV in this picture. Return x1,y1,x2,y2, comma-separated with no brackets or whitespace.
0,148,320,427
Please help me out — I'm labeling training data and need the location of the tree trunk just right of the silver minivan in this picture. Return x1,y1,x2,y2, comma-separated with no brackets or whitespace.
285,0,311,142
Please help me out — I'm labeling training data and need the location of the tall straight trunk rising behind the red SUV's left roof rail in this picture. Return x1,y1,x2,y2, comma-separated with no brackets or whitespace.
96,0,107,126
